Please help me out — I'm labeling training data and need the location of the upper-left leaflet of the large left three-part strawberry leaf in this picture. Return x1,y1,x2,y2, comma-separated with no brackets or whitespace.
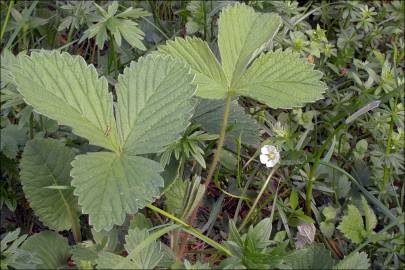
12,51,117,150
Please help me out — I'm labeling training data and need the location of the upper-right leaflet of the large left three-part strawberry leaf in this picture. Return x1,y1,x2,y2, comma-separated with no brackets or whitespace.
117,55,195,154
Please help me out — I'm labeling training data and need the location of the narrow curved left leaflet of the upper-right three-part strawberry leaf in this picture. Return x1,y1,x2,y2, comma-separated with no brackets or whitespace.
158,37,227,99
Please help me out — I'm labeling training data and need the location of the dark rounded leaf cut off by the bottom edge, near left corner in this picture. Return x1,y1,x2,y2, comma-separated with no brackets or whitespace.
21,231,70,269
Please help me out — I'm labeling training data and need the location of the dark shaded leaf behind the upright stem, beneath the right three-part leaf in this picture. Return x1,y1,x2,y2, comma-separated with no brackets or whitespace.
192,99,260,149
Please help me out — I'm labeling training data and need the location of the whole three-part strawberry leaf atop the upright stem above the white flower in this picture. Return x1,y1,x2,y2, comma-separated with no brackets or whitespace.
159,3,326,108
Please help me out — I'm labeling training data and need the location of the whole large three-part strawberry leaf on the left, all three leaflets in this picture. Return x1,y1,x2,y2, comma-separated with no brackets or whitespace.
13,52,194,230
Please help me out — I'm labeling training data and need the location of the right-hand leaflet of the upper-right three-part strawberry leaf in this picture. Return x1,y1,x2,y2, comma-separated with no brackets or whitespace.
235,51,327,109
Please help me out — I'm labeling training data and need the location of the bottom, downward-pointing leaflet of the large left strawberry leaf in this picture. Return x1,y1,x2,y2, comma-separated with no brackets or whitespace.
71,152,163,231
